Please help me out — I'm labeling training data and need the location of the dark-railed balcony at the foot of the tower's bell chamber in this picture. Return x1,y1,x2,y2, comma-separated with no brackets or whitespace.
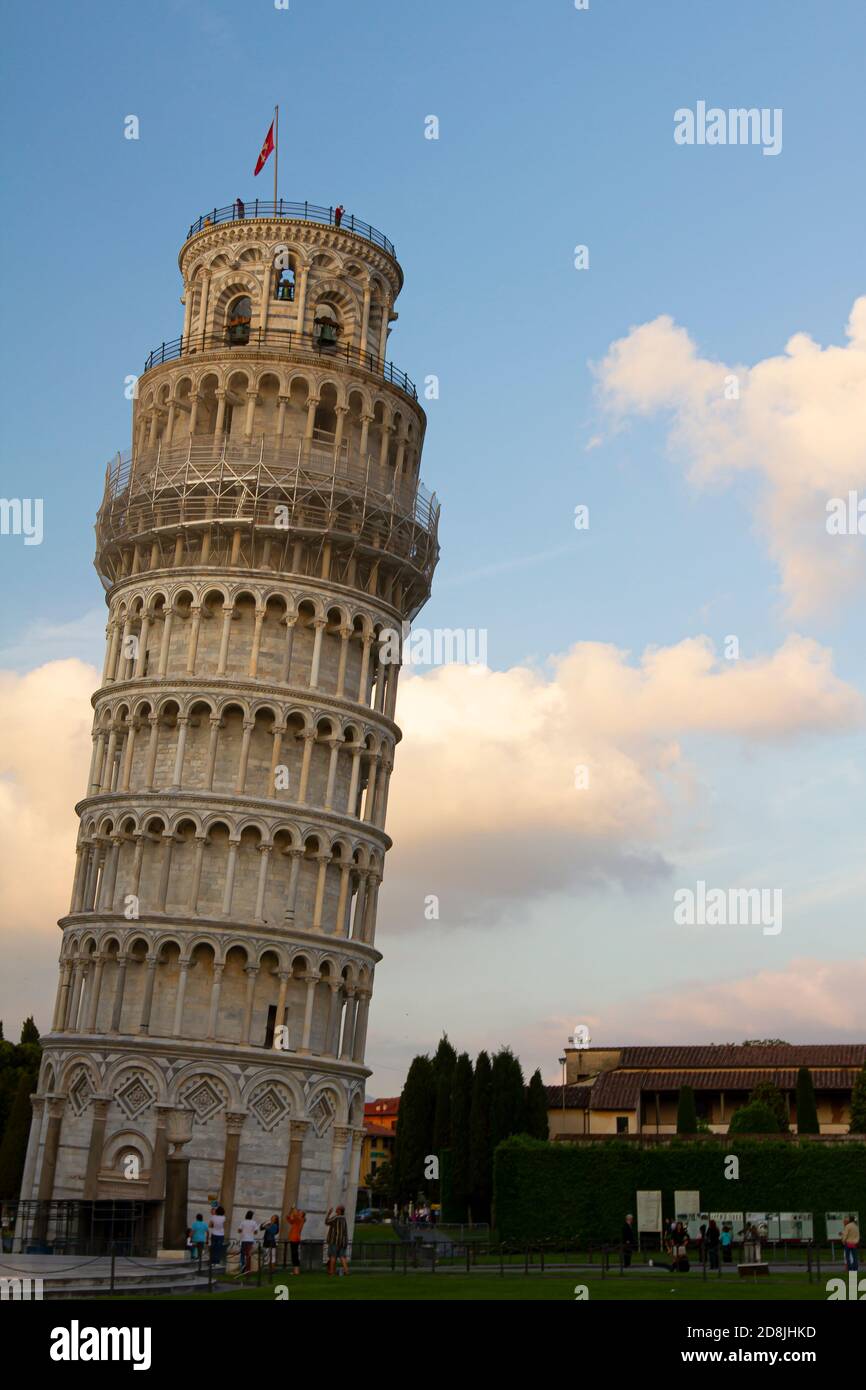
145,325,418,400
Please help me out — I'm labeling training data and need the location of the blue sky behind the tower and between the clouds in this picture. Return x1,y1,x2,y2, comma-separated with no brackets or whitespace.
0,0,866,1091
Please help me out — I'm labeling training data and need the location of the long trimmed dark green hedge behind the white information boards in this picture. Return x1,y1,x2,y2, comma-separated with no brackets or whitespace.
493,1137,866,1241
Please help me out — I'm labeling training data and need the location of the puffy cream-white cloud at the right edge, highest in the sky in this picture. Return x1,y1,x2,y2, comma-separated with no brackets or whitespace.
596,296,866,617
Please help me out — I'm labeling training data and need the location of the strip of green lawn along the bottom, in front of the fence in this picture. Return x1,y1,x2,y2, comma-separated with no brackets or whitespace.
159,1270,827,1302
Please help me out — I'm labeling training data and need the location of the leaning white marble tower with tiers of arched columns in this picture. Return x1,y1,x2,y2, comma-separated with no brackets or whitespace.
22,202,438,1248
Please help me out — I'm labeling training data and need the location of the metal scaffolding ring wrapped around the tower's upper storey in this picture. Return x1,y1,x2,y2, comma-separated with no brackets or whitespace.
96,438,439,606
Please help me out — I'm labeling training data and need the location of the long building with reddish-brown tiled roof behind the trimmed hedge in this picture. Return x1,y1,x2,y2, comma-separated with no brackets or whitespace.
546,1043,866,1138
